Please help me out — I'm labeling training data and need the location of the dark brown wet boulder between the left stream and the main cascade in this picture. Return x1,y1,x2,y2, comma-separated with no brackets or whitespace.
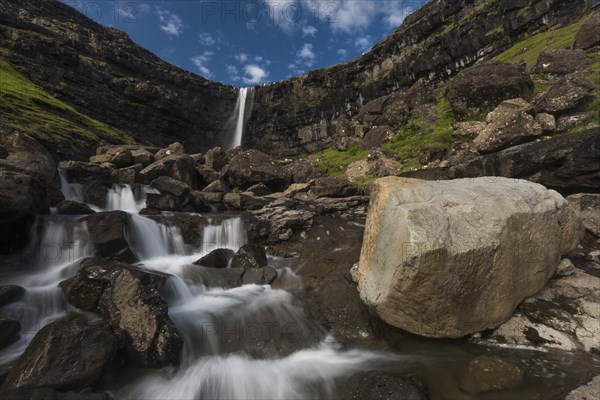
60,258,183,368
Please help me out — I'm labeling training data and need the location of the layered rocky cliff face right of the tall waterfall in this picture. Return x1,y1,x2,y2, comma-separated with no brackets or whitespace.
244,0,587,155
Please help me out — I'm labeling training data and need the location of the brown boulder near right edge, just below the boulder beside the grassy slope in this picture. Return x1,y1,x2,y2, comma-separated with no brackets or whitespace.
532,73,596,114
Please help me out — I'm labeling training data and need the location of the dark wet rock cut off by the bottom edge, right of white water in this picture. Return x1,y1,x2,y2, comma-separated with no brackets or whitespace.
341,371,429,400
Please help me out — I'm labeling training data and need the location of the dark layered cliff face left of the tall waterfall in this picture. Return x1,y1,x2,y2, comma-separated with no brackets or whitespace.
0,0,237,159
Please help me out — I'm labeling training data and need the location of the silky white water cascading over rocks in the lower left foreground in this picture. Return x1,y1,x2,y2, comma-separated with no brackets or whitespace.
0,171,398,399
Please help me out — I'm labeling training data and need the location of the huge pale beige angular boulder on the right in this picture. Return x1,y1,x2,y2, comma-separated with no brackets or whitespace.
357,177,582,338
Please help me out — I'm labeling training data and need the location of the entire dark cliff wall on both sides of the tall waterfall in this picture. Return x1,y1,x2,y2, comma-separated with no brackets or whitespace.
0,0,587,158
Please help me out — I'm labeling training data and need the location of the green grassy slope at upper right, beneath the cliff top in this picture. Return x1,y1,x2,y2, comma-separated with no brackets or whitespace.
496,17,589,67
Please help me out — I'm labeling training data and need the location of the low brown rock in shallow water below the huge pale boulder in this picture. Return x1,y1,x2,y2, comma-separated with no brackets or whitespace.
460,356,524,394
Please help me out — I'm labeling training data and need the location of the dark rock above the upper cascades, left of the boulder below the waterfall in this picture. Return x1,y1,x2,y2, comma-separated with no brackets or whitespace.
140,155,198,189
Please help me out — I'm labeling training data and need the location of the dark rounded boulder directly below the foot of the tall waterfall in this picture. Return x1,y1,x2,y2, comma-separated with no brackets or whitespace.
223,150,291,192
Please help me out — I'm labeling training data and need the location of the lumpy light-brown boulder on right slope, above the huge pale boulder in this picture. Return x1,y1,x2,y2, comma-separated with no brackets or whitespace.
473,99,543,153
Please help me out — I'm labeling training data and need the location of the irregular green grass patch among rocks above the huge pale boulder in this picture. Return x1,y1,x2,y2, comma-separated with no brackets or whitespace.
381,98,455,172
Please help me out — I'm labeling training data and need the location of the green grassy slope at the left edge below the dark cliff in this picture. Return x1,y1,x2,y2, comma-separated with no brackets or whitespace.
0,59,134,150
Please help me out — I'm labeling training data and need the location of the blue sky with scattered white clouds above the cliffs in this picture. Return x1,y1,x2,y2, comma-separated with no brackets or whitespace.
62,0,425,86
